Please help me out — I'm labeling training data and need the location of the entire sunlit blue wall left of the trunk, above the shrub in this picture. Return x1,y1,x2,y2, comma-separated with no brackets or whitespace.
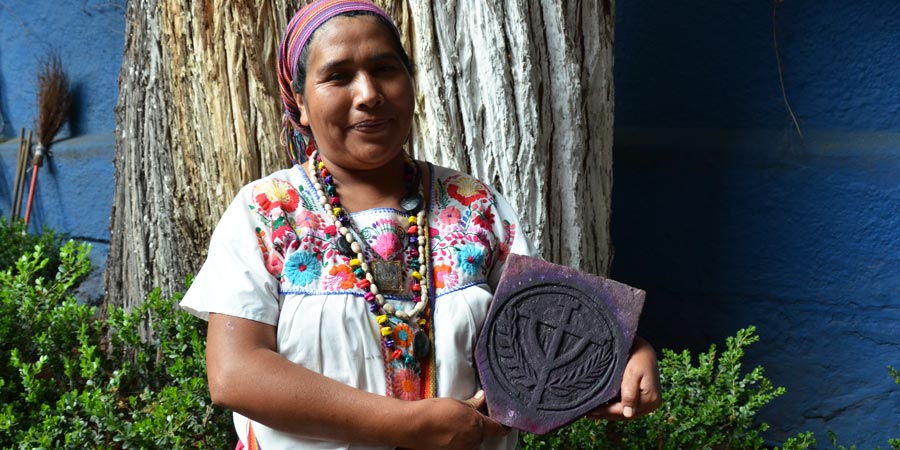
0,0,125,300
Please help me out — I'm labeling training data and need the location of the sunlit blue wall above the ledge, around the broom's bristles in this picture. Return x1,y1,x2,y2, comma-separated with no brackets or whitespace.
0,0,125,138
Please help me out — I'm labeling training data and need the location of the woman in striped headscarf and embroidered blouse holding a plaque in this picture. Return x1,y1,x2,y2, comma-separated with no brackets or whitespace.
182,0,659,450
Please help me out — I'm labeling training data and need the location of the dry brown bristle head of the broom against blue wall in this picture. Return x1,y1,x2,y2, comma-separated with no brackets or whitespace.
35,52,72,148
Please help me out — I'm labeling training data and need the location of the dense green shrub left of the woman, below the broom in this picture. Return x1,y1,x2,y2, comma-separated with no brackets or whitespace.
0,242,235,449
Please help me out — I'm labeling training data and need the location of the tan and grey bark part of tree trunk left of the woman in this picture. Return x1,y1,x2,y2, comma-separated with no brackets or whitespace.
106,0,297,330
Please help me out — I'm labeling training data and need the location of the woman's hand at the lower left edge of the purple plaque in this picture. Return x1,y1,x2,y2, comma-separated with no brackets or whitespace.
409,391,509,450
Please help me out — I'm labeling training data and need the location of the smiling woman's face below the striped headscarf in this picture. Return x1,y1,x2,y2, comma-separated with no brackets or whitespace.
295,16,414,170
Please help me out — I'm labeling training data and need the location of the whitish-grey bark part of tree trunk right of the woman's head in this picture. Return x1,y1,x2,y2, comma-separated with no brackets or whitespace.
409,0,614,274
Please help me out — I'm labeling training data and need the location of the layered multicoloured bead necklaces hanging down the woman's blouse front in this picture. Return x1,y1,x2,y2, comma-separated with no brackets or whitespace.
307,150,435,399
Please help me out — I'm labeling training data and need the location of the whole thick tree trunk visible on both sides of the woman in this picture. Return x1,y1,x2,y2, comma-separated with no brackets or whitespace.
106,0,614,324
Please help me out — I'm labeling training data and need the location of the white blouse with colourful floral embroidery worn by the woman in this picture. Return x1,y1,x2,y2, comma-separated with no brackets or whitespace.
181,166,533,450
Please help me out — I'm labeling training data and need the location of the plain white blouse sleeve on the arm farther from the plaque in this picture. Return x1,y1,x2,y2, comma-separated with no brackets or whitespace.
181,187,279,326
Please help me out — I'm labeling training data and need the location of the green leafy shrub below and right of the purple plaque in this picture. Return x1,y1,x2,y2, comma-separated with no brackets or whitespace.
520,326,815,450
